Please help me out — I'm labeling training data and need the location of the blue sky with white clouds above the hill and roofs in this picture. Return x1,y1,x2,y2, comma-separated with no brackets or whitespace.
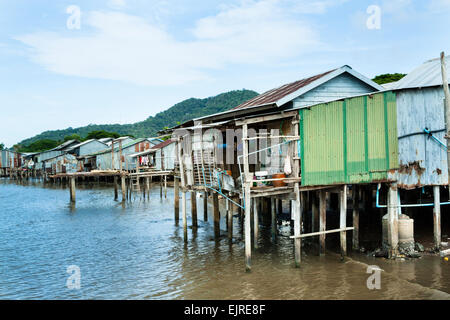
0,0,450,146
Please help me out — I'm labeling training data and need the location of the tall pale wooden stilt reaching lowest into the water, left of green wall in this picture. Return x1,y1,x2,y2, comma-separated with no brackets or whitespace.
242,124,252,272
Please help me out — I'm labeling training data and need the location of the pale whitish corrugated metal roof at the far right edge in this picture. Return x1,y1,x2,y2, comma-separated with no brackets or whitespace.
392,56,450,89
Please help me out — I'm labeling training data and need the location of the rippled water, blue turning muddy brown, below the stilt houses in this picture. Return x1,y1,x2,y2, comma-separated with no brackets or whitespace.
0,179,450,299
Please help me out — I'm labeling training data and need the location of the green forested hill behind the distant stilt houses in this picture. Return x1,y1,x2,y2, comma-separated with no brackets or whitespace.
15,89,258,146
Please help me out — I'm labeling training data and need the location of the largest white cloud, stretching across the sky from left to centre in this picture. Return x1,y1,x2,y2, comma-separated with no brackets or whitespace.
17,0,318,86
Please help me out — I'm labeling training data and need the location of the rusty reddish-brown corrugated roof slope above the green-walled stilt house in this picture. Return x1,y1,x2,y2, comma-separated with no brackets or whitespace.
233,69,337,110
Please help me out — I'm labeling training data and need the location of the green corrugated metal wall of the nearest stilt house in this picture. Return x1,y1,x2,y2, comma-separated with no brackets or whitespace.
299,92,398,186
